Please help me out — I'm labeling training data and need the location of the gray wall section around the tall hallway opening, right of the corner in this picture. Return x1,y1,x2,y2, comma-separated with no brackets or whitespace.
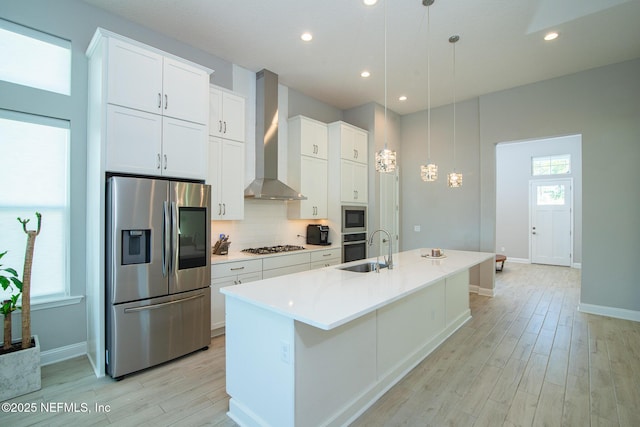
480,59,640,311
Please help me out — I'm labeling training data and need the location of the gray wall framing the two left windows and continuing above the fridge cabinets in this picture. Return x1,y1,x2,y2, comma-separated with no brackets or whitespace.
0,0,233,351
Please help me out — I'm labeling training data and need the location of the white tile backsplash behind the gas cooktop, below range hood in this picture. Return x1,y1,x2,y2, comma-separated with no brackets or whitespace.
211,199,326,252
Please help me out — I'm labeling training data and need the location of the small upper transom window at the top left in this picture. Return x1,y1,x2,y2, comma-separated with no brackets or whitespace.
0,19,71,95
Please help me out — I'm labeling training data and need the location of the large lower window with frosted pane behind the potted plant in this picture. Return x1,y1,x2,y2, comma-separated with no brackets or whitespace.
0,110,70,302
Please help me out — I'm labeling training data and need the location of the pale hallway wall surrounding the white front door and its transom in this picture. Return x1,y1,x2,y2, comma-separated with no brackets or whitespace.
496,135,582,263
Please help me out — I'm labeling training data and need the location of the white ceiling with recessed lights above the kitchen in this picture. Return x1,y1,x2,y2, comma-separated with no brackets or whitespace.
83,0,640,114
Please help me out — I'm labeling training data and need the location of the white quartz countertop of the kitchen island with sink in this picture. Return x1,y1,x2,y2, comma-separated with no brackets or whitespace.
220,249,495,330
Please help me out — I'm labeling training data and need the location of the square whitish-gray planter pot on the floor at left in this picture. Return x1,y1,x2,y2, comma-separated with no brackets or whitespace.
0,335,42,401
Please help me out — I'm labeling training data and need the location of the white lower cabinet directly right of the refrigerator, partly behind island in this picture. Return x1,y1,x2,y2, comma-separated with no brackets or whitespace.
211,259,262,331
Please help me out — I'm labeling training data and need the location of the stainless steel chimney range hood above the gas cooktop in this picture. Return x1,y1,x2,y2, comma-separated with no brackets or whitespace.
244,70,307,200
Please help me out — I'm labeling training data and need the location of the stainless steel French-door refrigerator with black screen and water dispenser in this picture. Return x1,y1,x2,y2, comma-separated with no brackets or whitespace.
105,176,211,378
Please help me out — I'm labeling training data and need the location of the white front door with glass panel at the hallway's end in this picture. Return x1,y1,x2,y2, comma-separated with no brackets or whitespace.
530,179,573,266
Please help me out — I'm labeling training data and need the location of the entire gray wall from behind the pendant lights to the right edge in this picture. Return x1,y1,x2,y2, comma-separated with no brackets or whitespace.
401,59,640,311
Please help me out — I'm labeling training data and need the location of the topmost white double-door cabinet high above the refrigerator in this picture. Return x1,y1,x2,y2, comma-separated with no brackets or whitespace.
107,38,209,124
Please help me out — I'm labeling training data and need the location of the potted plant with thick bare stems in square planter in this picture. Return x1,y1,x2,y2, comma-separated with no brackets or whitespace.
0,212,42,401
